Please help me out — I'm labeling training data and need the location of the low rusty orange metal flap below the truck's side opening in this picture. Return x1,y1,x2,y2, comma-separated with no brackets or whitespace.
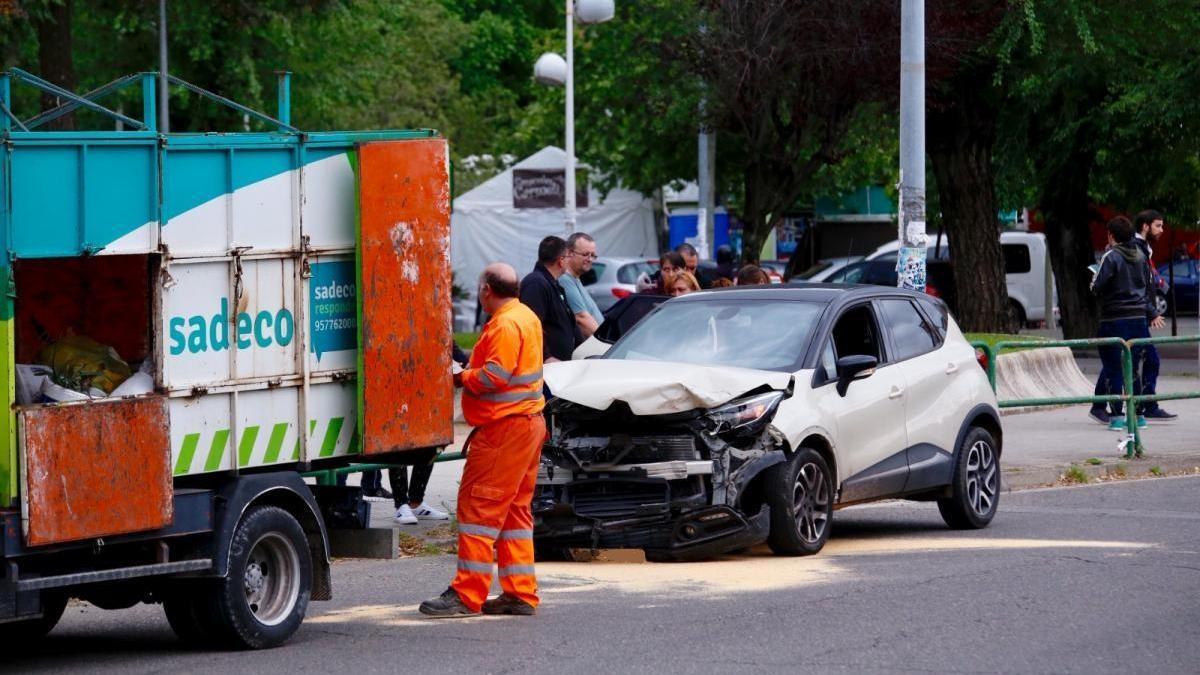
18,396,174,546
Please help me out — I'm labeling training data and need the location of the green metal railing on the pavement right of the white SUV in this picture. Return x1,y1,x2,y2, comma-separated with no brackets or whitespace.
971,335,1200,458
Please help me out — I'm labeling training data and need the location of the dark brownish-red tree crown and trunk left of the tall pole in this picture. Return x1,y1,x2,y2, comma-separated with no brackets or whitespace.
697,0,899,256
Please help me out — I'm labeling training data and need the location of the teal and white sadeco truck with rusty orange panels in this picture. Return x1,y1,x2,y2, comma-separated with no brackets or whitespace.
0,70,452,647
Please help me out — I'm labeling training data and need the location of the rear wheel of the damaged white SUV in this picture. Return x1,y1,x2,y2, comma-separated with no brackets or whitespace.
937,426,1000,530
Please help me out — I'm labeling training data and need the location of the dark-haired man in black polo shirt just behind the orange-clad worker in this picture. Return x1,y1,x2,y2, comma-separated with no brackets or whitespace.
521,237,583,363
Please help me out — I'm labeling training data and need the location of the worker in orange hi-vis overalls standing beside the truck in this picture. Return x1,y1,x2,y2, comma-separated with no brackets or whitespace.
420,263,546,617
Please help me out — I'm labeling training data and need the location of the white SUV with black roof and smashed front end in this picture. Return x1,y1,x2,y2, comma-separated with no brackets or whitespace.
533,286,1002,560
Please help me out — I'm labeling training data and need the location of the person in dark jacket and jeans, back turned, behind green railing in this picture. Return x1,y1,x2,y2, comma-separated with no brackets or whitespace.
1088,216,1163,424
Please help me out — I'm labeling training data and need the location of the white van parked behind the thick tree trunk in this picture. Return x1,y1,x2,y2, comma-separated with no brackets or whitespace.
866,231,1058,325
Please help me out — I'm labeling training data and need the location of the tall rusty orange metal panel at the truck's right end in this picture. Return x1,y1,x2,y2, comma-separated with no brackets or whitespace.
358,138,454,455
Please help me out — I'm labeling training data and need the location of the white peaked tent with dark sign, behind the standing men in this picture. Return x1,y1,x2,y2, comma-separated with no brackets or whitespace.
450,147,659,330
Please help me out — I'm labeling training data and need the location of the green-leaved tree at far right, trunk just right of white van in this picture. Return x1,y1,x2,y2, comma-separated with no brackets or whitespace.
1000,0,1200,338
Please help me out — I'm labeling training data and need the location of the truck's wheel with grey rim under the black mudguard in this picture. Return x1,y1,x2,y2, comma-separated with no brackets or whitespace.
207,506,312,650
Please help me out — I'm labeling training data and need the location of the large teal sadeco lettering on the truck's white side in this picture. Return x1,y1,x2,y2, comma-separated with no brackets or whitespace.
167,298,296,356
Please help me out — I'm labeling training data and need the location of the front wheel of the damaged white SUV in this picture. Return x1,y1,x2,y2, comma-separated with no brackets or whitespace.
767,448,833,555
